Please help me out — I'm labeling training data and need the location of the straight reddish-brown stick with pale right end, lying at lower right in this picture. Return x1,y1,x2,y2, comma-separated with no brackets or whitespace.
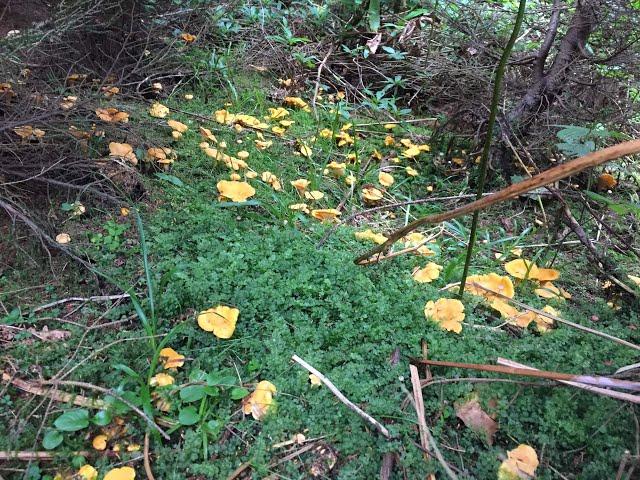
411,359,640,403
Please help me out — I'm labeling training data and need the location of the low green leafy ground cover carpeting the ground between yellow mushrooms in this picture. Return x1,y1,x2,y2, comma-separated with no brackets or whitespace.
0,75,638,479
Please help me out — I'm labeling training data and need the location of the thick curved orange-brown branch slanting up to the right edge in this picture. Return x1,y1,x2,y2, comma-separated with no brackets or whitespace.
355,140,640,265
